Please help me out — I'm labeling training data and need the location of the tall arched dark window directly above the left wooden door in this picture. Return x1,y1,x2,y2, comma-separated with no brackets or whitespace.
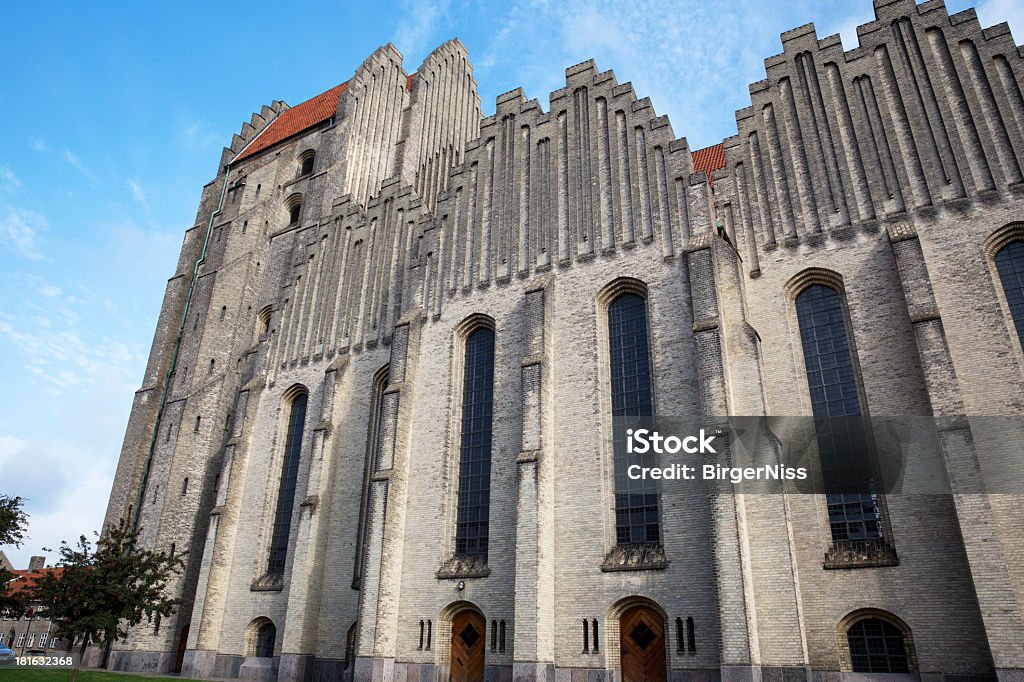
455,327,495,560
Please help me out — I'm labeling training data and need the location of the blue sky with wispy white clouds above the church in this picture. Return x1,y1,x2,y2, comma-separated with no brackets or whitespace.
0,0,1024,567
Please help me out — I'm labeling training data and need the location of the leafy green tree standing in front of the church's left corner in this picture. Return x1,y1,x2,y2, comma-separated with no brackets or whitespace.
33,518,184,682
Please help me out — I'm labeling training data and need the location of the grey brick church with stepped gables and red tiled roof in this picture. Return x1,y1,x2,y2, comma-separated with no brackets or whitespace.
99,0,1024,682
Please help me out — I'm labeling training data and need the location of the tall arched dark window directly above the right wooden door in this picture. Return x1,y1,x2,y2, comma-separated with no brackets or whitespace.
608,293,662,546
